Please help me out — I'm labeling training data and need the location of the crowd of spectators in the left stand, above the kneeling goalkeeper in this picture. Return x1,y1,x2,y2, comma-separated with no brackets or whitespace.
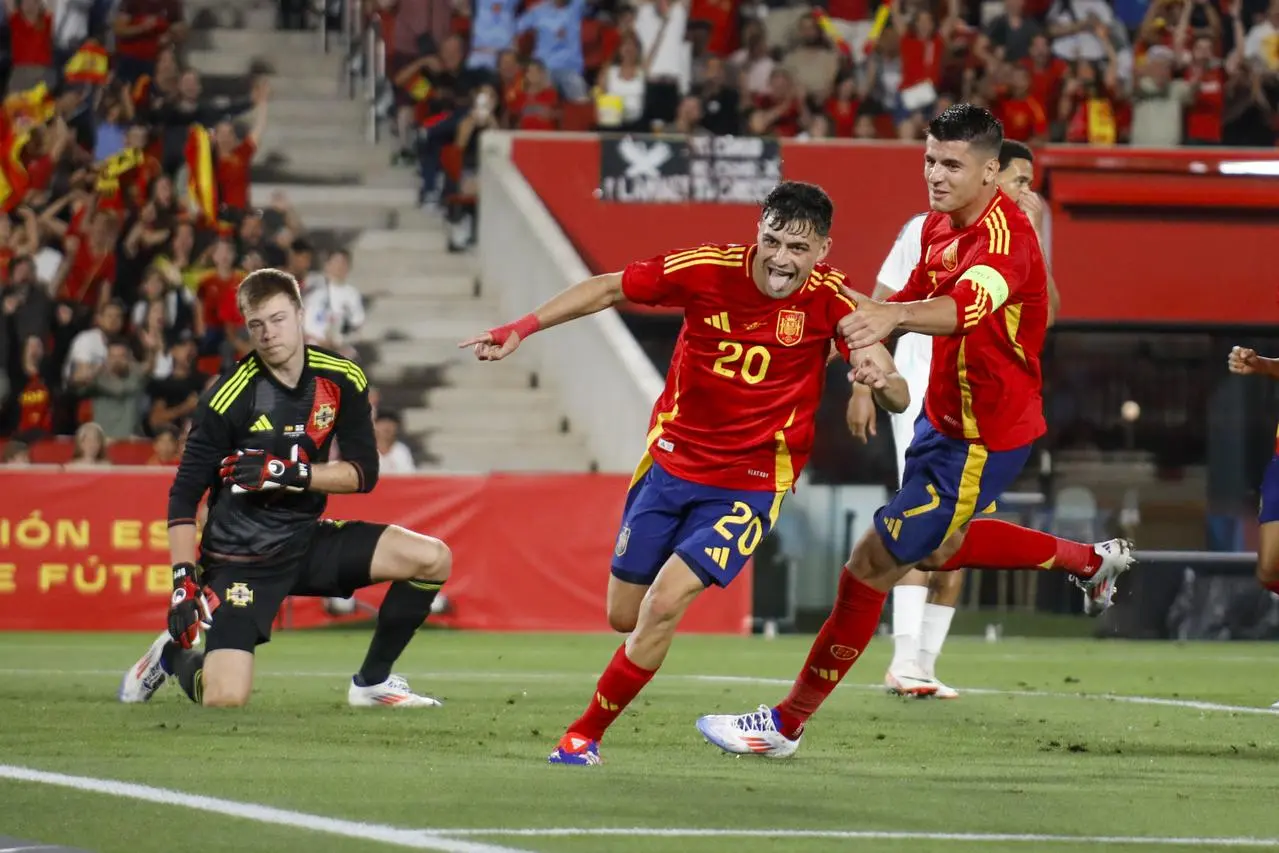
0,0,373,464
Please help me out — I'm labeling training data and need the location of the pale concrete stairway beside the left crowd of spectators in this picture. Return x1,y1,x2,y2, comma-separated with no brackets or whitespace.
188,9,592,472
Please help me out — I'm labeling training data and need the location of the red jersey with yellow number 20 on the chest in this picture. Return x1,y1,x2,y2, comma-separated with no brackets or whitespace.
622,246,854,492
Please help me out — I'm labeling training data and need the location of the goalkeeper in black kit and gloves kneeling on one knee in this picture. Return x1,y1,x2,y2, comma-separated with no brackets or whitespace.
119,270,451,707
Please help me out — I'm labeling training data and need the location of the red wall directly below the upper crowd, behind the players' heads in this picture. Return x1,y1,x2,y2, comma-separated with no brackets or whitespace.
512,136,1279,324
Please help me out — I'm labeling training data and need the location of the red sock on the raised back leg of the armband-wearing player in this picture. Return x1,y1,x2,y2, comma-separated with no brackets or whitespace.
941,518,1101,578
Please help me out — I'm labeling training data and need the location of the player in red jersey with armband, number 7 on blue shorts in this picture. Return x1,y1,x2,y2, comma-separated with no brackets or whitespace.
697,104,1132,758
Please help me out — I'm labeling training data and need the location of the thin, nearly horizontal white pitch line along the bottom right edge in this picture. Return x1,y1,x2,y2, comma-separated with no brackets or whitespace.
435,826,1279,848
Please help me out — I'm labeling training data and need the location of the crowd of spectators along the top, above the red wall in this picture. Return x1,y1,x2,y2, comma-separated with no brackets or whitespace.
366,0,1279,205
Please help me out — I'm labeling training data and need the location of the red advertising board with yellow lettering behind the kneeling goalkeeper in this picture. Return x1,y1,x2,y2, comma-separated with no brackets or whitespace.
0,469,751,633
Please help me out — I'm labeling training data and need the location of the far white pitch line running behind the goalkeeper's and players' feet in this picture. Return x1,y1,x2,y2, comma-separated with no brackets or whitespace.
0,669,1279,716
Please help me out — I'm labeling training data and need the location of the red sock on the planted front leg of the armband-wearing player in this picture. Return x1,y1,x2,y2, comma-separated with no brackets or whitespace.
776,569,888,739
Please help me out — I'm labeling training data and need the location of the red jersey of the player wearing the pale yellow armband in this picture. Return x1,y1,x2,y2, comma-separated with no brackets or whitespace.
889,191,1048,450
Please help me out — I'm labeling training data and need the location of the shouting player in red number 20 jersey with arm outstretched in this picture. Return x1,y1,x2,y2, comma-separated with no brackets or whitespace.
460,182,908,765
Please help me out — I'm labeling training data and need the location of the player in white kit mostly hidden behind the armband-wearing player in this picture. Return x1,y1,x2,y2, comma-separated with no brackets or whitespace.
848,139,1058,700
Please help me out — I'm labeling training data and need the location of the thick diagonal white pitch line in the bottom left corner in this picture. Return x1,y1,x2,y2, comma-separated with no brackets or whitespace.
0,765,531,853
